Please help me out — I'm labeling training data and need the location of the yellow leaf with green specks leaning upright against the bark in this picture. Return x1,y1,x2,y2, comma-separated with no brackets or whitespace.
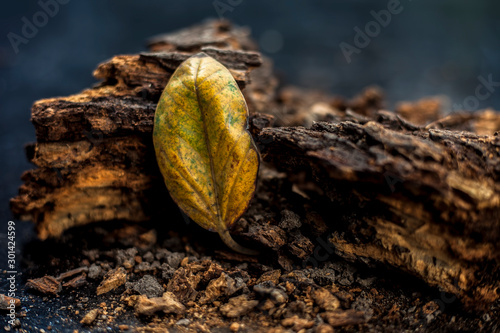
153,53,259,254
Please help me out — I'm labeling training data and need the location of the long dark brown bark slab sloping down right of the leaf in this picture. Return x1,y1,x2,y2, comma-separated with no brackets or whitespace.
260,113,500,304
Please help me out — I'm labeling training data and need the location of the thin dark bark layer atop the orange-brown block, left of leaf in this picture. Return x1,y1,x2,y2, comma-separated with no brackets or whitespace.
31,95,156,146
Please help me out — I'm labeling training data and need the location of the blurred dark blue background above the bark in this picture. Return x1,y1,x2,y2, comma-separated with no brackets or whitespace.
0,0,500,244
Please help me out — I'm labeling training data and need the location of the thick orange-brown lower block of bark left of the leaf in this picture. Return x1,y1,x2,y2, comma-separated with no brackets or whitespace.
11,108,271,239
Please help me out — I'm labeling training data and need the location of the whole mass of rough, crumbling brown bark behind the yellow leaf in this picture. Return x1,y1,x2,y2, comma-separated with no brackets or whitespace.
11,22,500,316
